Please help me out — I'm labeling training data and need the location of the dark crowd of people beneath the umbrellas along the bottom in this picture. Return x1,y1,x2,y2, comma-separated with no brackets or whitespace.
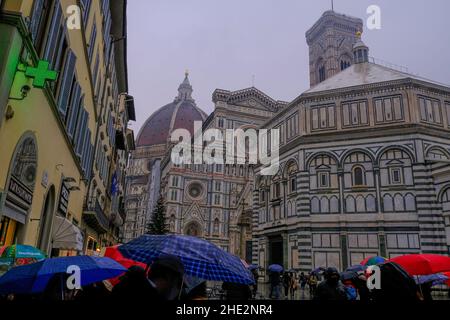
0,256,448,303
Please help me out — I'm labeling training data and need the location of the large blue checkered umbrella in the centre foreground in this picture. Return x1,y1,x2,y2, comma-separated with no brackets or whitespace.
119,234,254,284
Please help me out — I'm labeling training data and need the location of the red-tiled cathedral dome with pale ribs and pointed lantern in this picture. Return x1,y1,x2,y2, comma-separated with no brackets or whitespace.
136,72,207,147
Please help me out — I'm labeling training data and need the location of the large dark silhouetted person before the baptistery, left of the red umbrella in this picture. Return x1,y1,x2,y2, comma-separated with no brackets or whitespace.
314,268,347,301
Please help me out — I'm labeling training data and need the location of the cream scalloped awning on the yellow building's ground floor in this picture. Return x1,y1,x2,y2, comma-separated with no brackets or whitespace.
52,216,83,251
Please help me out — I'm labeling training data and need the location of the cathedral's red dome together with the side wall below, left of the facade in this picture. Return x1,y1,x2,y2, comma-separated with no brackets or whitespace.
123,72,206,242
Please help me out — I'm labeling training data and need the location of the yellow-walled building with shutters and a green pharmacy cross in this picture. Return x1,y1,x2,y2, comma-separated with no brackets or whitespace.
0,0,134,255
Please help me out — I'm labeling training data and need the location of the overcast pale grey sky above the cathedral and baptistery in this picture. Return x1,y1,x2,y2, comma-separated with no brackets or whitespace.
128,0,450,135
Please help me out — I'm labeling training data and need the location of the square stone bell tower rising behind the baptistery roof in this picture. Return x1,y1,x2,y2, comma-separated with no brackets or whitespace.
306,10,363,87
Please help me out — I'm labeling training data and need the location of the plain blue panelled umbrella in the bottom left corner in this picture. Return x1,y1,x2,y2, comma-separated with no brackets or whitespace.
0,256,127,294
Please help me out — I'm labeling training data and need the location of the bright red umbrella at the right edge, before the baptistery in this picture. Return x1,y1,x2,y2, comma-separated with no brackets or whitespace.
389,254,450,276
